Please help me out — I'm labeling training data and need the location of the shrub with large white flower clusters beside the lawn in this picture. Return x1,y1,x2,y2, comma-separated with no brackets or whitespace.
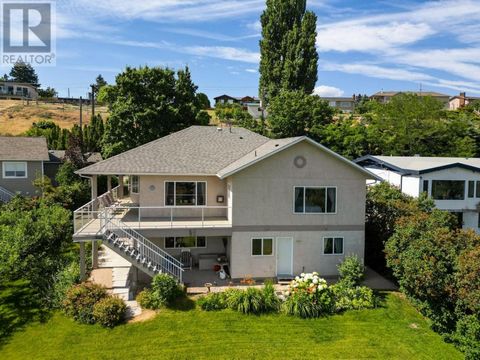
283,272,335,318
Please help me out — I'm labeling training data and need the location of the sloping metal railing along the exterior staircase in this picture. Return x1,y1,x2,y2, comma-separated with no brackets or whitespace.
105,217,183,282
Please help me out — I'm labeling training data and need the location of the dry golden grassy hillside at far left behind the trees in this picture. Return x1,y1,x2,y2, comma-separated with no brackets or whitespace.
0,100,108,135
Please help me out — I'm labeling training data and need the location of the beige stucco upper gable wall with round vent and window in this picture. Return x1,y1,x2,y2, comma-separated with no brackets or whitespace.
232,142,366,227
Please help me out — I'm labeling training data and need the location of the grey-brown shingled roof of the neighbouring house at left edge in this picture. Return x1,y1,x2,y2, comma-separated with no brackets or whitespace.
0,136,49,161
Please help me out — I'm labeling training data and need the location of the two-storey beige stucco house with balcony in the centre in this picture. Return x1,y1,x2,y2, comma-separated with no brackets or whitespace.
74,126,378,292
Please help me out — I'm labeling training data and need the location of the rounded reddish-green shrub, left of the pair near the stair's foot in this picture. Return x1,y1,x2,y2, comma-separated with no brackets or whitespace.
63,283,108,324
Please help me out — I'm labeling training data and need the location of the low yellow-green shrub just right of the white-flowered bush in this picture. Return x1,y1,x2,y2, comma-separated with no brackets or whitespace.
330,282,376,311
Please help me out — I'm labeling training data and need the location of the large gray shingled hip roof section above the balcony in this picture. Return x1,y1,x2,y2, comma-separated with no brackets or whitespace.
77,126,269,175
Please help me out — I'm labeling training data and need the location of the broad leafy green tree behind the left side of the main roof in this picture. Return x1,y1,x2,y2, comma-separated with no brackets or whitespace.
102,66,200,157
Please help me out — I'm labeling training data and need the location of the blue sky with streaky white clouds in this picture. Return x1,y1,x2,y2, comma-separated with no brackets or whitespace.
0,0,480,98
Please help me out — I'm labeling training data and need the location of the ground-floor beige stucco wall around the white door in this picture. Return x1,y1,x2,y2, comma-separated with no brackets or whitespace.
230,231,364,278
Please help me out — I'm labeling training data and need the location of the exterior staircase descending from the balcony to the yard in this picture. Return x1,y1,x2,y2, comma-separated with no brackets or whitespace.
103,216,183,283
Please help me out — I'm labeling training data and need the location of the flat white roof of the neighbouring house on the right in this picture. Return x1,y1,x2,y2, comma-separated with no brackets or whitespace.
354,155,480,174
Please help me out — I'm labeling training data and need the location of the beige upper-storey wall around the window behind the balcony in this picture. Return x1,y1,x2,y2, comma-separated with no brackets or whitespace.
131,175,227,217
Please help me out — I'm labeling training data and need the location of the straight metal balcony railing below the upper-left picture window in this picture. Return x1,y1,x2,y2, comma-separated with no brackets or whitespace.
114,206,231,229
